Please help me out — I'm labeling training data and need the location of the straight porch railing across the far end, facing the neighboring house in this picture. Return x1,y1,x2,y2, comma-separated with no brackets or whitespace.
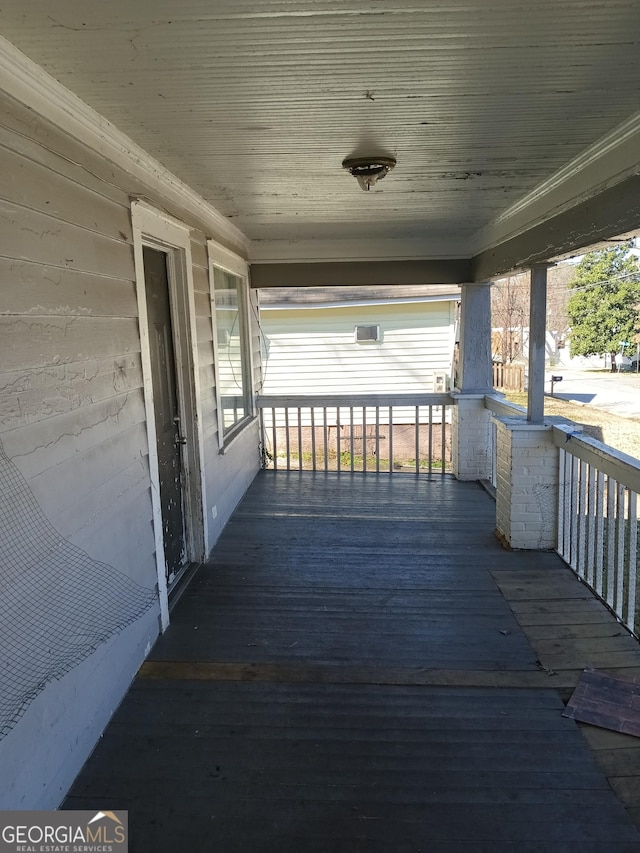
257,394,453,474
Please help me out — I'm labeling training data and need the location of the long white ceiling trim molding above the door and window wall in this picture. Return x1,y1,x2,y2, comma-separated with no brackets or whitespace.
0,36,250,253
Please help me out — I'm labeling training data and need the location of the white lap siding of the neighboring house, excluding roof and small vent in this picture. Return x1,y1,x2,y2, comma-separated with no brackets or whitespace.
261,301,454,394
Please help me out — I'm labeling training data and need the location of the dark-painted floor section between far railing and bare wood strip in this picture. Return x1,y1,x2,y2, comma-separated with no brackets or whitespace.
151,474,536,670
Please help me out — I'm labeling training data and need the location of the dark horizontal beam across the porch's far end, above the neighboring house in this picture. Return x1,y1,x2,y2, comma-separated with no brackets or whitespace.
251,259,472,288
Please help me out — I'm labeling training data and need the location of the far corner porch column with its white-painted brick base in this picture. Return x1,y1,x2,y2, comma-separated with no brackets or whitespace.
451,282,493,480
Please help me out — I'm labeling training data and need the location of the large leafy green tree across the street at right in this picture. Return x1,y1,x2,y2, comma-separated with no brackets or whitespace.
567,246,640,370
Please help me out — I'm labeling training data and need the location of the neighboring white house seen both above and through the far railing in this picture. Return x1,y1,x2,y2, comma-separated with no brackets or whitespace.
260,285,460,470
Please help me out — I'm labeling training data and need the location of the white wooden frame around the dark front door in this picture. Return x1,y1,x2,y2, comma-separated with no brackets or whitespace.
131,201,208,631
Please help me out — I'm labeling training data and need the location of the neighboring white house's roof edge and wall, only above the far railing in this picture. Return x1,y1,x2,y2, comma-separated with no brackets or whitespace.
260,285,460,394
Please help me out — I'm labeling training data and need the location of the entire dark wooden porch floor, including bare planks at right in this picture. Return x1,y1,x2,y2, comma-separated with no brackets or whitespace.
63,472,640,853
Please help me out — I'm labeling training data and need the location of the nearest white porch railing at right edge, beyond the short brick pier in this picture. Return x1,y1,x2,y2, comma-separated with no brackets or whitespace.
553,426,640,635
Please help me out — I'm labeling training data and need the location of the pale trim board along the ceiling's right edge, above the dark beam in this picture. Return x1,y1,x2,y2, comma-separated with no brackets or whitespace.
473,113,640,254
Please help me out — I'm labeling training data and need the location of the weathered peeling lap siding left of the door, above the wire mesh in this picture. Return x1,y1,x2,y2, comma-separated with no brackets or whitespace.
0,114,154,564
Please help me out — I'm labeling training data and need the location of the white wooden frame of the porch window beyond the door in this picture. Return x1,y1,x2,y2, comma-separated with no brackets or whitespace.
207,240,256,453
